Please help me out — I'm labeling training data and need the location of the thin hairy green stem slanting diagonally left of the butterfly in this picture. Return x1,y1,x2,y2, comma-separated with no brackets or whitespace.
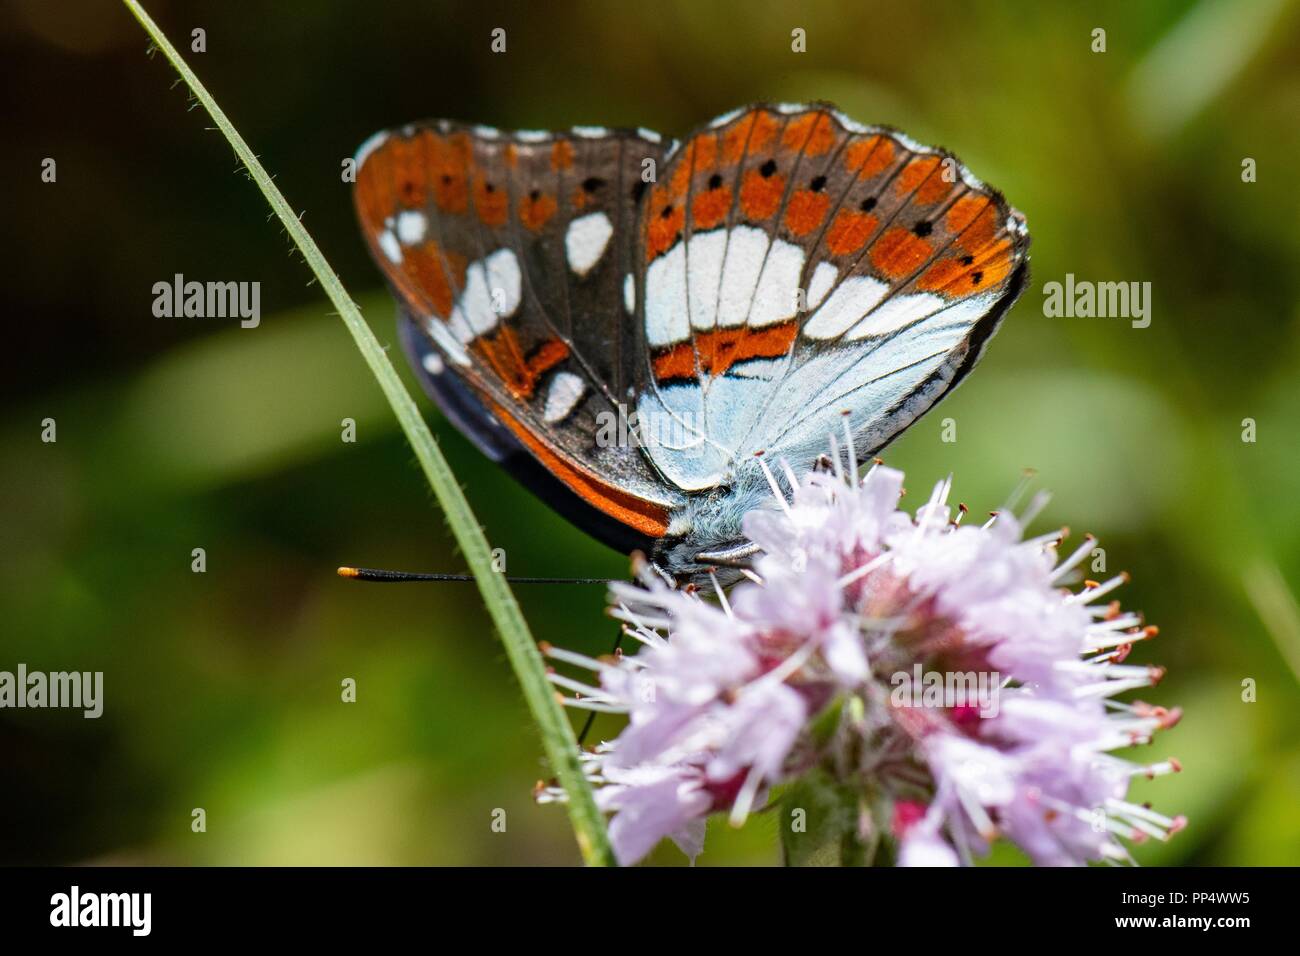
122,0,614,865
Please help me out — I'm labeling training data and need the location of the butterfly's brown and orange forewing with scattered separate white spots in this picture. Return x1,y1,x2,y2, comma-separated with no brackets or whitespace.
356,122,676,537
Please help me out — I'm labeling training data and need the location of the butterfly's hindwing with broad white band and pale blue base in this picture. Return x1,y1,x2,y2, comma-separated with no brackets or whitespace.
638,105,1028,490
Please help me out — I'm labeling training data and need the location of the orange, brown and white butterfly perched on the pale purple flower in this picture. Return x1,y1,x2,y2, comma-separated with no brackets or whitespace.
354,104,1030,584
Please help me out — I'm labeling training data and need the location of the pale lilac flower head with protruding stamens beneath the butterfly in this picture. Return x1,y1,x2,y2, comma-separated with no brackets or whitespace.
533,444,1184,865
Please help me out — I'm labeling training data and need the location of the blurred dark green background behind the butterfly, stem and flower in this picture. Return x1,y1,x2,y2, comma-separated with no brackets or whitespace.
0,0,1300,865
